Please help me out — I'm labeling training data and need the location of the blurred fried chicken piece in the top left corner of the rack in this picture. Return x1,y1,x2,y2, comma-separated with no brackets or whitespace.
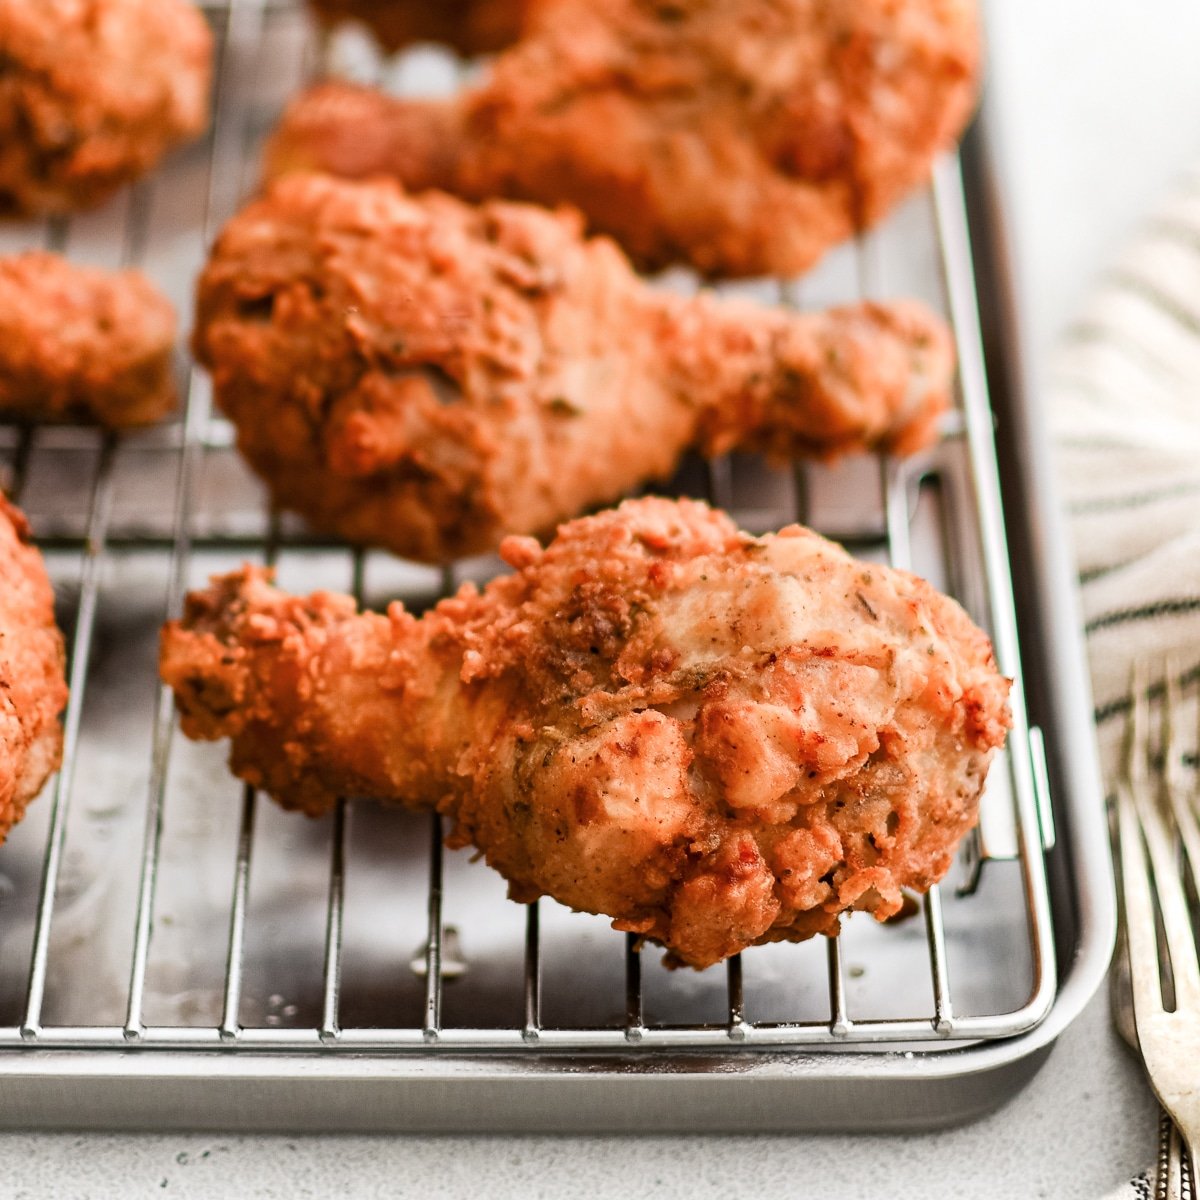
0,0,212,214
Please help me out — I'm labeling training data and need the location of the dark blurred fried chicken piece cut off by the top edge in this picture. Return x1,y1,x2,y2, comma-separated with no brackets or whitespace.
311,0,545,58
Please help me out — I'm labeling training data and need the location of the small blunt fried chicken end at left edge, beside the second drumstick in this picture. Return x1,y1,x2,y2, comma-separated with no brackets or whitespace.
0,251,175,428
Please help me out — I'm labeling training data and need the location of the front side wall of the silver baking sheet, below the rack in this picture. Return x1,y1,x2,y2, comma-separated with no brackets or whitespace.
0,1039,1049,1133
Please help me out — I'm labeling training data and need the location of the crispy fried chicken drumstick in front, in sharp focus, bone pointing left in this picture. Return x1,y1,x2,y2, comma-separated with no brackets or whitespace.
161,499,1009,967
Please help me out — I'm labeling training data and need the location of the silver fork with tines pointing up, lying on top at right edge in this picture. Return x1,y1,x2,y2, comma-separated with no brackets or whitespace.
1117,664,1200,1195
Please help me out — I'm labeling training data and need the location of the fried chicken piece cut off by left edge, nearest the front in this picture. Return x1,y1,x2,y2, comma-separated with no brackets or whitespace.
0,493,67,841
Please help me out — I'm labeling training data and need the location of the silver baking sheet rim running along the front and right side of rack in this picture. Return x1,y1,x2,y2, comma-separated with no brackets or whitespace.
0,108,1116,1133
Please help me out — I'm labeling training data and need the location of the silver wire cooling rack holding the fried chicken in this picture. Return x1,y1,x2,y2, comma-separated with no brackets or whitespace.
0,0,1056,1061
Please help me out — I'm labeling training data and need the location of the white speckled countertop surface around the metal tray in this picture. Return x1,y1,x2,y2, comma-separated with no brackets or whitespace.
9,0,1200,1200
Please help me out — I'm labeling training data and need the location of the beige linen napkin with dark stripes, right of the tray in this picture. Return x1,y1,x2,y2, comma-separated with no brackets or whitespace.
1046,168,1200,1200
